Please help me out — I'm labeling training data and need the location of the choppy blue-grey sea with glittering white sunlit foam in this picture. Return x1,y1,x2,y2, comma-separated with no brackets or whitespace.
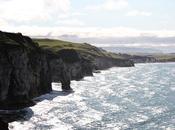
10,63,175,130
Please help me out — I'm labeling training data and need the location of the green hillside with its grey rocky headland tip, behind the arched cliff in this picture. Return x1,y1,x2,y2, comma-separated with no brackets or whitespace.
33,39,134,69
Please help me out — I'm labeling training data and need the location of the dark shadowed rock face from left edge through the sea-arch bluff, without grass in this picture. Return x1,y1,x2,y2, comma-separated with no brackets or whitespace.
0,32,92,109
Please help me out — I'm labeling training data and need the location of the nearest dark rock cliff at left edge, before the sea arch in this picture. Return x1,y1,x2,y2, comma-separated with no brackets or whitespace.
0,32,52,109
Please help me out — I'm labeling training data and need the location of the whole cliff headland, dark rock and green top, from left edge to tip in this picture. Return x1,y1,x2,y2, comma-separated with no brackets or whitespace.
0,32,134,109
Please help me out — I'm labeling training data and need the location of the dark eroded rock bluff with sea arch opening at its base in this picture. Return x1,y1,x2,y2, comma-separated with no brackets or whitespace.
50,49,92,90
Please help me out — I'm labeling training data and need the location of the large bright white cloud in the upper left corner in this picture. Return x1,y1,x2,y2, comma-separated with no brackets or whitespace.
0,0,70,22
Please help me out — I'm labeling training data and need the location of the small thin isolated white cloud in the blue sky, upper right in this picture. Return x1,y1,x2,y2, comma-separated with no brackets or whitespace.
126,10,152,16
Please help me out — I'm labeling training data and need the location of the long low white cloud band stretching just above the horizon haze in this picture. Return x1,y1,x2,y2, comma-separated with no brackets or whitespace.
1,25,175,38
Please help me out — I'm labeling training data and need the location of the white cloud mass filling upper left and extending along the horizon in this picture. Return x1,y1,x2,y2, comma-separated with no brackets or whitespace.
0,0,175,38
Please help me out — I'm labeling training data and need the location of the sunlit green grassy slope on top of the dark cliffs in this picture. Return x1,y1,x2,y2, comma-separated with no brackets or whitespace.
33,39,124,59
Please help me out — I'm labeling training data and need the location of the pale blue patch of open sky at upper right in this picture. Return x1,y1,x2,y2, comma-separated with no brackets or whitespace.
73,0,175,30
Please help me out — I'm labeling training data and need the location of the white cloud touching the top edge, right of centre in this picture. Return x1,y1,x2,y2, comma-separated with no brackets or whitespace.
86,0,128,11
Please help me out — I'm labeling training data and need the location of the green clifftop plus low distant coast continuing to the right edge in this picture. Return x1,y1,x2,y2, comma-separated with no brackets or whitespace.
33,39,175,62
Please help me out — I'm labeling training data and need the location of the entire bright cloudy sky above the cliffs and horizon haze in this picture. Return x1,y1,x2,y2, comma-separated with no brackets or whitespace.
0,0,175,38
